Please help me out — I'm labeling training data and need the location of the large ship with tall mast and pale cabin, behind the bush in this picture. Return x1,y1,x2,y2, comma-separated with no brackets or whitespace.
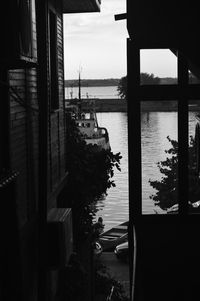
65,74,111,150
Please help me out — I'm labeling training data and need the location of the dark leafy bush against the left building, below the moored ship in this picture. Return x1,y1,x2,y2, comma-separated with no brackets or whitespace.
66,115,121,244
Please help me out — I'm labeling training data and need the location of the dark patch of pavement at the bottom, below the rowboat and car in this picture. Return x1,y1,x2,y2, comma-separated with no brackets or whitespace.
99,252,130,297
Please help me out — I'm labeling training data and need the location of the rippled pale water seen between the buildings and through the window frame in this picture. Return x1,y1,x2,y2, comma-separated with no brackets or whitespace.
65,87,196,230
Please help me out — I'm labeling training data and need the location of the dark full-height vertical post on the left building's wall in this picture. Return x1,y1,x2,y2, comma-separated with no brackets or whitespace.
36,0,48,301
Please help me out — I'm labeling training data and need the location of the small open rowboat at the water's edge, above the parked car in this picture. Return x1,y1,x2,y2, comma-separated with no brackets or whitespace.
98,221,128,251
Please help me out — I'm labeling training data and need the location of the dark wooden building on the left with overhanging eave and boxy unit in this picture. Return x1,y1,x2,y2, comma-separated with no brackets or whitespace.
0,0,100,301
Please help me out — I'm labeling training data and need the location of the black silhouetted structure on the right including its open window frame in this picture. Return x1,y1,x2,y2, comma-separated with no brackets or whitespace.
126,0,200,301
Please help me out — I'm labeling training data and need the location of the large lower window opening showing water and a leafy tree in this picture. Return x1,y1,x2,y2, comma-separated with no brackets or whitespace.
141,101,177,214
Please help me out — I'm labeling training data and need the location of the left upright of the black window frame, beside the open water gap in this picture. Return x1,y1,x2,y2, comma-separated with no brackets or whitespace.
127,39,142,221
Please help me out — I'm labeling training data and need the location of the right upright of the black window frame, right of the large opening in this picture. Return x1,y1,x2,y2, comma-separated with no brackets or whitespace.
178,53,189,216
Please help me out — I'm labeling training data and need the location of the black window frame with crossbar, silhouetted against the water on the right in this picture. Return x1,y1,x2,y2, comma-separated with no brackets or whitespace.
127,39,200,220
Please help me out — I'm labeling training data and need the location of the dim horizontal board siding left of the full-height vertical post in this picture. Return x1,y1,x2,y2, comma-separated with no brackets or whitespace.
9,69,38,227
